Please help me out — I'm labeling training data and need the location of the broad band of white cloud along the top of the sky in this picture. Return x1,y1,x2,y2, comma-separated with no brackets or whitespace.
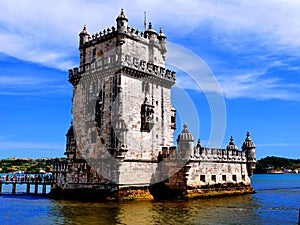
0,0,300,69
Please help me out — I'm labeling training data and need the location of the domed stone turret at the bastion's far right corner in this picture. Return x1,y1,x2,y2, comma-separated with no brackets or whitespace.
242,132,256,177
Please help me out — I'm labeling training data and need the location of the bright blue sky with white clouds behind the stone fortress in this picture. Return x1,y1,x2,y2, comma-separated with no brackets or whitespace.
0,0,300,158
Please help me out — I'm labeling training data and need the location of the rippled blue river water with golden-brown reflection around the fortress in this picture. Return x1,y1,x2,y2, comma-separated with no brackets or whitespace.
0,174,300,225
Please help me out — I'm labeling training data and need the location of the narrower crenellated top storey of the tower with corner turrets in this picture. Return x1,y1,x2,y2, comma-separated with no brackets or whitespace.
79,10,170,80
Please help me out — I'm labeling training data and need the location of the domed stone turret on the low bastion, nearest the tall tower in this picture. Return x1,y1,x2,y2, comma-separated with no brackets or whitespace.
177,124,194,158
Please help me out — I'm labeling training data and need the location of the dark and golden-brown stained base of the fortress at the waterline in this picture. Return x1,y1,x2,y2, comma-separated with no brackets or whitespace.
49,183,255,202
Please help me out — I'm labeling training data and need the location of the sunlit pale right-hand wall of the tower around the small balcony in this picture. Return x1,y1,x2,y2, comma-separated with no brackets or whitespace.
121,76,174,160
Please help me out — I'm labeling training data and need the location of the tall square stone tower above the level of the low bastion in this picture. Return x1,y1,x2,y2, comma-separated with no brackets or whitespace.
69,10,176,160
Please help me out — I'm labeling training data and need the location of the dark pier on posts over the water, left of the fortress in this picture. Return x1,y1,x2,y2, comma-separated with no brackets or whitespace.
0,181,52,195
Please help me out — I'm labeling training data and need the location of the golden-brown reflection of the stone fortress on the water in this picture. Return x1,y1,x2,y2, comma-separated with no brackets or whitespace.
52,195,258,225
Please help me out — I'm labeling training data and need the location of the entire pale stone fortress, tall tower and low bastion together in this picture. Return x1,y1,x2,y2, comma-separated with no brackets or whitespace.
51,10,256,199
